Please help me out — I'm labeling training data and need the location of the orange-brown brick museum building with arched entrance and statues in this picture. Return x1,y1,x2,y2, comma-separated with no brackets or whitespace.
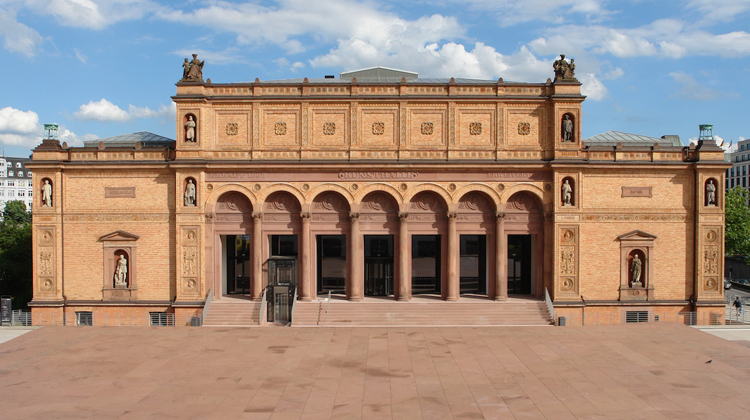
28,63,727,322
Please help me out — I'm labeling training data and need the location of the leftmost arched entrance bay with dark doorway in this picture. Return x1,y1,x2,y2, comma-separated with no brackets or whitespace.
213,191,256,299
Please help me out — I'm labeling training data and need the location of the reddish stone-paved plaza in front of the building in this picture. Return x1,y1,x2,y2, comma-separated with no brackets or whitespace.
0,324,750,420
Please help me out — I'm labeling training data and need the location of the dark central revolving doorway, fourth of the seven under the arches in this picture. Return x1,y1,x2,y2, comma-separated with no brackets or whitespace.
365,235,393,296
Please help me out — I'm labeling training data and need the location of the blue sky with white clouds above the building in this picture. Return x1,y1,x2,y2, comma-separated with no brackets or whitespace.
0,0,750,156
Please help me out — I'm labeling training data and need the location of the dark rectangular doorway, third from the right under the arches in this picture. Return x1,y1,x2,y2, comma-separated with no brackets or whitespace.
411,235,440,295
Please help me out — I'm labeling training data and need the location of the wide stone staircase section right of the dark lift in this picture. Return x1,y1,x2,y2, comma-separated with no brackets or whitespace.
290,299,553,327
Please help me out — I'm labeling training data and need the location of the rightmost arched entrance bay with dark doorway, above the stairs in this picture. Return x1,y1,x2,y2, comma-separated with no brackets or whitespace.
503,192,544,297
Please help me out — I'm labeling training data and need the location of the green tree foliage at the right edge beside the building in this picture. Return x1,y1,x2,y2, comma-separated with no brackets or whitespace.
724,187,750,262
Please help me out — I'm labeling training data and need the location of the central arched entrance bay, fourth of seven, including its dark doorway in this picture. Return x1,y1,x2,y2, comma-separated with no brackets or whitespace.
359,191,402,297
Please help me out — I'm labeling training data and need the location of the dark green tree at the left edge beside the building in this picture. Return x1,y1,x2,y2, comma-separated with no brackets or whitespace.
0,201,33,309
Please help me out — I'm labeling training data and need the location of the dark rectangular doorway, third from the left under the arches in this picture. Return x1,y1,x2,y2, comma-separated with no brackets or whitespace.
316,235,346,293
